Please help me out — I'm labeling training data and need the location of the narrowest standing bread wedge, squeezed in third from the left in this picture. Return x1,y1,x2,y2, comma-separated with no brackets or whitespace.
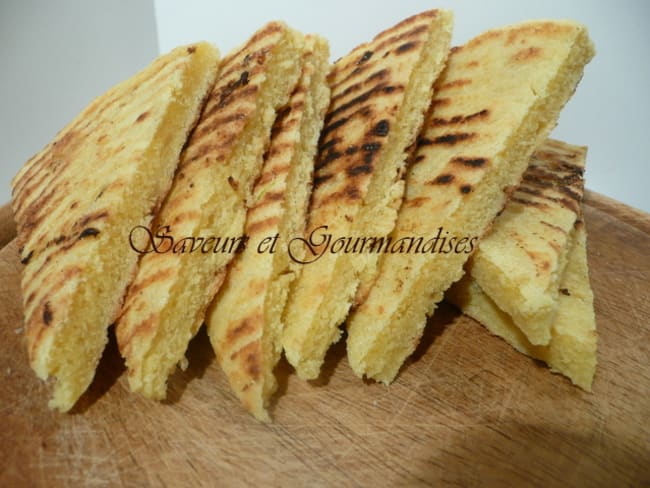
206,36,330,421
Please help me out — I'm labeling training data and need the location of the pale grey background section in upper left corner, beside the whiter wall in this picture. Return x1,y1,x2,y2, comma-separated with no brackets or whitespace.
0,0,158,205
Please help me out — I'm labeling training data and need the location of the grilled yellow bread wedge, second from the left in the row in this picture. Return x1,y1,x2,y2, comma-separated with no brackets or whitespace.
117,22,304,399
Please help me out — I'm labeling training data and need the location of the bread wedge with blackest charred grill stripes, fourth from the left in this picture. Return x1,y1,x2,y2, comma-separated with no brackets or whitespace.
283,10,452,379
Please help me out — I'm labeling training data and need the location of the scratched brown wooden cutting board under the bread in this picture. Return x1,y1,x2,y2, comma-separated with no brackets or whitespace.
0,193,650,487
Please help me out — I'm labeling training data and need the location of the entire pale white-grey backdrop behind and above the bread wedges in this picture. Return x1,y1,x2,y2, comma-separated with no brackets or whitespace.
0,0,650,211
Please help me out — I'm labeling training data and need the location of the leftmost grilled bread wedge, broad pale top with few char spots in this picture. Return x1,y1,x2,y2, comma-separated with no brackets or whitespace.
13,43,218,411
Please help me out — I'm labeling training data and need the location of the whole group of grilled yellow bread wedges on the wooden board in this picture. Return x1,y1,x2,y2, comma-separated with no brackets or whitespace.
12,10,597,421
